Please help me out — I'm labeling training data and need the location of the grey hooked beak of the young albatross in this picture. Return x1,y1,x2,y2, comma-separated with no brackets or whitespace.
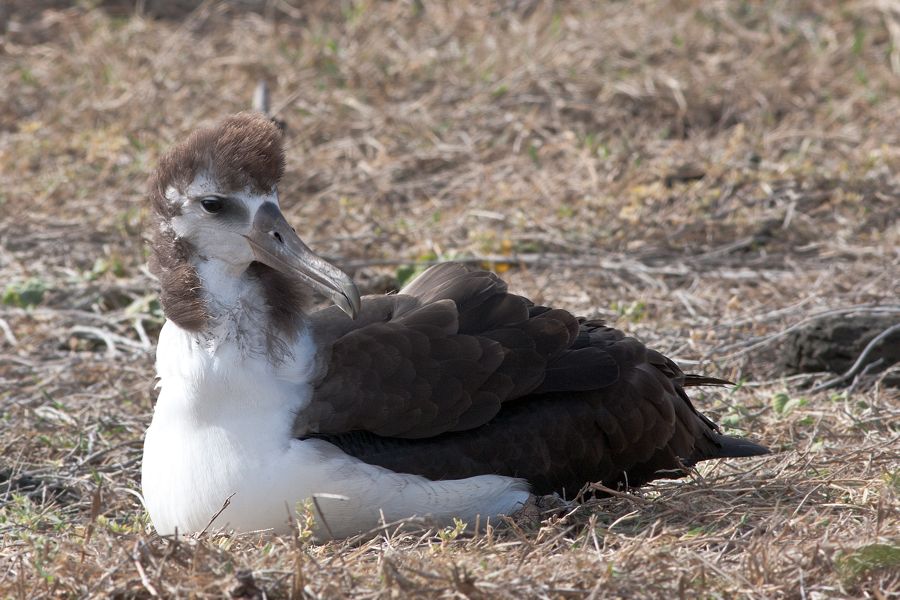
244,202,359,319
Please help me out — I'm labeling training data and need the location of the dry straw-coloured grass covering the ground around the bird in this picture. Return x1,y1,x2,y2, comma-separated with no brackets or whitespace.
0,0,900,598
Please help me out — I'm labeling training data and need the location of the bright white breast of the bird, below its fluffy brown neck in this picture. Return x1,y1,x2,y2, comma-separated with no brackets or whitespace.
142,322,312,533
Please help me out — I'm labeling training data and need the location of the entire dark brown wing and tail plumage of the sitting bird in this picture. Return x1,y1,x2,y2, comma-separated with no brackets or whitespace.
296,263,767,496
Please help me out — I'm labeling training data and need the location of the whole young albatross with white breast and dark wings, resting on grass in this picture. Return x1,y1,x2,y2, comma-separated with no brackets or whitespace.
142,113,767,538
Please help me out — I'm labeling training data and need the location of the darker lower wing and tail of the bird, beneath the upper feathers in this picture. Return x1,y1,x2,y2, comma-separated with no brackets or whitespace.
314,322,767,497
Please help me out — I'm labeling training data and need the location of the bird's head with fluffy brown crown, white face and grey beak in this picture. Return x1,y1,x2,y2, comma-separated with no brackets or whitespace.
150,113,360,331
